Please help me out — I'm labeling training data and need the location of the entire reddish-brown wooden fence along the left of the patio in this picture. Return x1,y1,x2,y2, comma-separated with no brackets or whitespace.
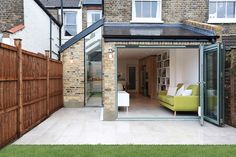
0,40,63,147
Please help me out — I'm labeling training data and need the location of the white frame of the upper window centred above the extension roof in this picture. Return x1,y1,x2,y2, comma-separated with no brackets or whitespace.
130,0,163,23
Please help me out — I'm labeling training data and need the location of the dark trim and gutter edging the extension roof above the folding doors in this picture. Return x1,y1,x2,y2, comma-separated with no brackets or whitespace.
103,23,219,43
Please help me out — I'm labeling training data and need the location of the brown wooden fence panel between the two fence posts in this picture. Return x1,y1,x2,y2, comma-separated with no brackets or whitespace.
22,51,47,132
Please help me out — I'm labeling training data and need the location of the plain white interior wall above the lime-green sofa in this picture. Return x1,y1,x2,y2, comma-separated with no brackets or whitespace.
170,49,199,87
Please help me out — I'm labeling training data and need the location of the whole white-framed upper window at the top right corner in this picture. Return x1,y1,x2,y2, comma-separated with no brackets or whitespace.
209,0,236,23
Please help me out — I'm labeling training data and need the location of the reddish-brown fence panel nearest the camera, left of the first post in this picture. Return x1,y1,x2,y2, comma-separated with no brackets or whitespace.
0,43,18,147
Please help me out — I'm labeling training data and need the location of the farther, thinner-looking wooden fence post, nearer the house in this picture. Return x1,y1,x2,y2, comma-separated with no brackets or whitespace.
45,50,50,116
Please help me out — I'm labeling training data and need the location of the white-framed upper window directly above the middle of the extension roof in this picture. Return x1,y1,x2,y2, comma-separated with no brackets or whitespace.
132,0,161,23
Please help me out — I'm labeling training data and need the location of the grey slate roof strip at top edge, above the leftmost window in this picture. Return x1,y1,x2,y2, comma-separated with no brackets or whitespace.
40,0,81,8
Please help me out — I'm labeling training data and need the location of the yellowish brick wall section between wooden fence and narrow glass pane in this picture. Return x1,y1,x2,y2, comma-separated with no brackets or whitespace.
62,40,85,107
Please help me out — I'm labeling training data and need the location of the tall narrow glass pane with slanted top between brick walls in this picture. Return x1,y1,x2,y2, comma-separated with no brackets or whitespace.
85,28,102,106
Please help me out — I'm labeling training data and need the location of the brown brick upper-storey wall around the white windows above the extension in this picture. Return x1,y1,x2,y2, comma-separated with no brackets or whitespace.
104,0,236,34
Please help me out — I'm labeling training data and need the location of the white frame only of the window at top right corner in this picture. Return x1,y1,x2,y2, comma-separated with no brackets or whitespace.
208,0,236,23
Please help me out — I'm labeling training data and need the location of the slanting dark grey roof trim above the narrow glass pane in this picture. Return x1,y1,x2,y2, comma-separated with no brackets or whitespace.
59,19,104,52
